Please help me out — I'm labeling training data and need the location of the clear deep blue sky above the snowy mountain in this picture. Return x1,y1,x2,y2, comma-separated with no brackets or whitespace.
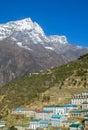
0,0,88,47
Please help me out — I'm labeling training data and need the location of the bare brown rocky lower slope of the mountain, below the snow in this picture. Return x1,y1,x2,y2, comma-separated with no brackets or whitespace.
0,41,65,85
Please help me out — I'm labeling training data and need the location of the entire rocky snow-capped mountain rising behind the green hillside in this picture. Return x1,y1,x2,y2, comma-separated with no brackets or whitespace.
0,18,88,85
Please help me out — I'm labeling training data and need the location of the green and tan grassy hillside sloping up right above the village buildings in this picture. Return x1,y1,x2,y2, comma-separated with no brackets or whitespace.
0,54,88,111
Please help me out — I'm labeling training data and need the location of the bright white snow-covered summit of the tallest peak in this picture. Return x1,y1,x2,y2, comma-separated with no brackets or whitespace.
0,18,44,41
